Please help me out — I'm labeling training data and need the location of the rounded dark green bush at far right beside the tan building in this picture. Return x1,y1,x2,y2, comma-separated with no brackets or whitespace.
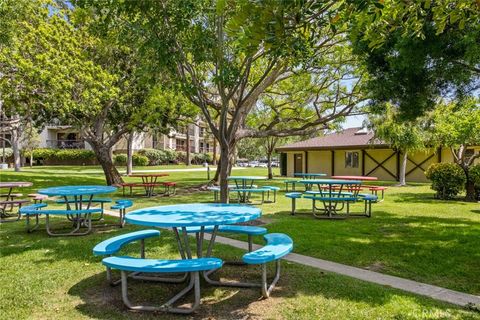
425,163,467,199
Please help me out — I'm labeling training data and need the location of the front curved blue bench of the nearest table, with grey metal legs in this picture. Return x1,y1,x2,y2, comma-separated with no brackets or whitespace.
102,257,223,314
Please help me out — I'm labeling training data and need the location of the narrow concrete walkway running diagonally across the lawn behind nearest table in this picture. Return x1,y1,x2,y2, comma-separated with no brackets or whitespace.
105,210,480,307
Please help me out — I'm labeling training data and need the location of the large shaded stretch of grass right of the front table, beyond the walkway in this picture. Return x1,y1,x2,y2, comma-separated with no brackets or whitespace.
266,210,480,295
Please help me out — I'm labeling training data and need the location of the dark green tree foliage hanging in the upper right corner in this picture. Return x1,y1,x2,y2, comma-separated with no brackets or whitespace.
350,0,480,120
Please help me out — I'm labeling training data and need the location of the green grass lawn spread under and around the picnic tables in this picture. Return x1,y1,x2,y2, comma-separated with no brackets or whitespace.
0,167,480,319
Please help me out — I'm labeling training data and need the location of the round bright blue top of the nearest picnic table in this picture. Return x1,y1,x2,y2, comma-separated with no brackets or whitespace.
125,203,262,228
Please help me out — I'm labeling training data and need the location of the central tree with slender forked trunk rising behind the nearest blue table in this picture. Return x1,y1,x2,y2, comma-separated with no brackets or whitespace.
78,0,366,202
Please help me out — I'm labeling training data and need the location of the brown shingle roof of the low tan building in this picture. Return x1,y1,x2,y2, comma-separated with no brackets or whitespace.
276,128,388,151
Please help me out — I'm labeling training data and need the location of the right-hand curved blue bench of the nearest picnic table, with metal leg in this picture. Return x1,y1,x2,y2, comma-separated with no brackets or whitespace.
242,233,293,298
